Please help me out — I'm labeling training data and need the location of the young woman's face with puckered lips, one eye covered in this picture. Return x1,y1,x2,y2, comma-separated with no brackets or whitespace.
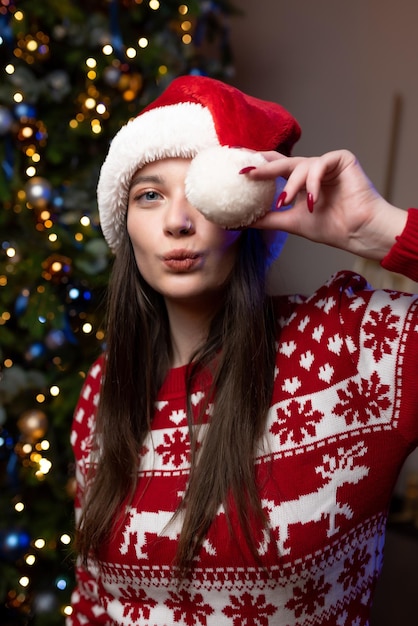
127,158,240,303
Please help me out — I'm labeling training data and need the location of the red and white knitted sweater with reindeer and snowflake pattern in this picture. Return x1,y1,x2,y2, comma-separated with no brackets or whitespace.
67,210,418,626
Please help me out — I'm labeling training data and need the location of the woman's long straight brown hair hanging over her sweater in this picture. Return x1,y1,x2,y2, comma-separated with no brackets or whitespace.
77,229,276,574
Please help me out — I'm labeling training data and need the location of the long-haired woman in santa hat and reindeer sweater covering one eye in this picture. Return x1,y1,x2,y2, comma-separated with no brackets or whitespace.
68,76,418,626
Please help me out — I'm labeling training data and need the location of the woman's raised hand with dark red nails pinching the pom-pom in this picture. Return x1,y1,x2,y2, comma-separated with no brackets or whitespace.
247,150,407,260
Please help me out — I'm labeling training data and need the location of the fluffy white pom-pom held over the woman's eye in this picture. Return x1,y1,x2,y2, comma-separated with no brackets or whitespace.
186,146,276,228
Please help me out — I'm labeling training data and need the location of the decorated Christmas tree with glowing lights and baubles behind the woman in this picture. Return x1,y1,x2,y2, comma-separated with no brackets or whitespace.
0,0,236,626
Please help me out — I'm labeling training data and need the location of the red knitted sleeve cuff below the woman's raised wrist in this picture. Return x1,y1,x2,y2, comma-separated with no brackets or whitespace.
381,209,418,282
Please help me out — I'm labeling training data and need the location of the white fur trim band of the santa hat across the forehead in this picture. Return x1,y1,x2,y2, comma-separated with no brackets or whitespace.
97,102,219,251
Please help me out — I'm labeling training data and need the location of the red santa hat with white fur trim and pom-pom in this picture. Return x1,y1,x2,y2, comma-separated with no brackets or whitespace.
97,76,300,252
